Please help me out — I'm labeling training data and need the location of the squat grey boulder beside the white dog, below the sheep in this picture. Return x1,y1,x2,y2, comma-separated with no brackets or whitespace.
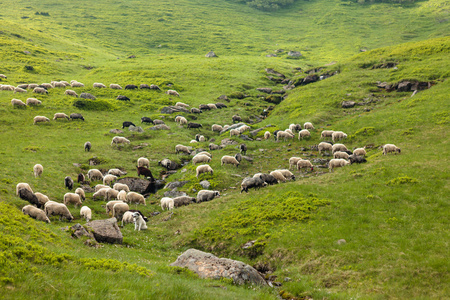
85,218,123,244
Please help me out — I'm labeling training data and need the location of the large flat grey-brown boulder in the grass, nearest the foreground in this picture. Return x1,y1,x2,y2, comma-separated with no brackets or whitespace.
170,249,266,285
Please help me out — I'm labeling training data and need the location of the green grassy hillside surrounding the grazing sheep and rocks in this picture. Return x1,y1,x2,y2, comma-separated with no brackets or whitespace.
0,0,450,299
